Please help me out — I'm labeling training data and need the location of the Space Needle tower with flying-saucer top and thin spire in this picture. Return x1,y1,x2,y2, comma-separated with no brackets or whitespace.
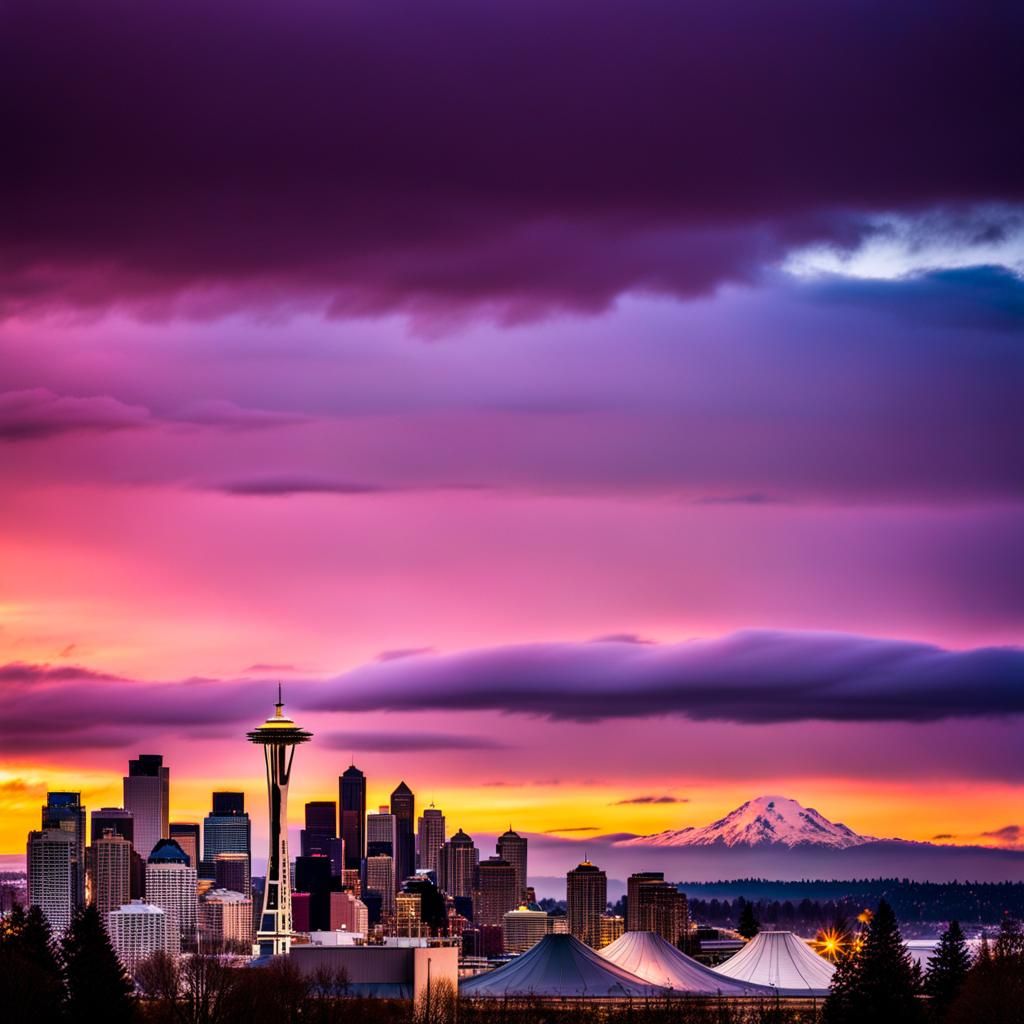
247,683,312,956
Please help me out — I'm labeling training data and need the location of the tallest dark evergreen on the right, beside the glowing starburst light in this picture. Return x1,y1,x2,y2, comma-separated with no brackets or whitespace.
824,900,921,1024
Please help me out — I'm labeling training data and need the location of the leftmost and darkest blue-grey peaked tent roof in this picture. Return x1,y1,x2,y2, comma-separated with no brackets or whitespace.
459,935,665,999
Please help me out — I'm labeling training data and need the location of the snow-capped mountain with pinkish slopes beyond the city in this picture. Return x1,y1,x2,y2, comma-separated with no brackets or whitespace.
615,797,876,850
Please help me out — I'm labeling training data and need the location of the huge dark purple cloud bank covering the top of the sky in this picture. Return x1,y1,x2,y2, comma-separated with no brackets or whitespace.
0,0,1024,316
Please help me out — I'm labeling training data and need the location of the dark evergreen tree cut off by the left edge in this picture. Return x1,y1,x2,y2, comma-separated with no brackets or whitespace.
0,905,65,1024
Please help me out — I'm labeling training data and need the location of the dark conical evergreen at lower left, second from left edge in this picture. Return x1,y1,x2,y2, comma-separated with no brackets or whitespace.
61,906,135,1024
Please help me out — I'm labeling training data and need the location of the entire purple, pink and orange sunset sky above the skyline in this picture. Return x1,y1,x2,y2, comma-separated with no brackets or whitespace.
0,0,1024,855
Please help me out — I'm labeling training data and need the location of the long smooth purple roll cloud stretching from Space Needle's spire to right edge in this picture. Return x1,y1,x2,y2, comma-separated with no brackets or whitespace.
310,630,1024,723
